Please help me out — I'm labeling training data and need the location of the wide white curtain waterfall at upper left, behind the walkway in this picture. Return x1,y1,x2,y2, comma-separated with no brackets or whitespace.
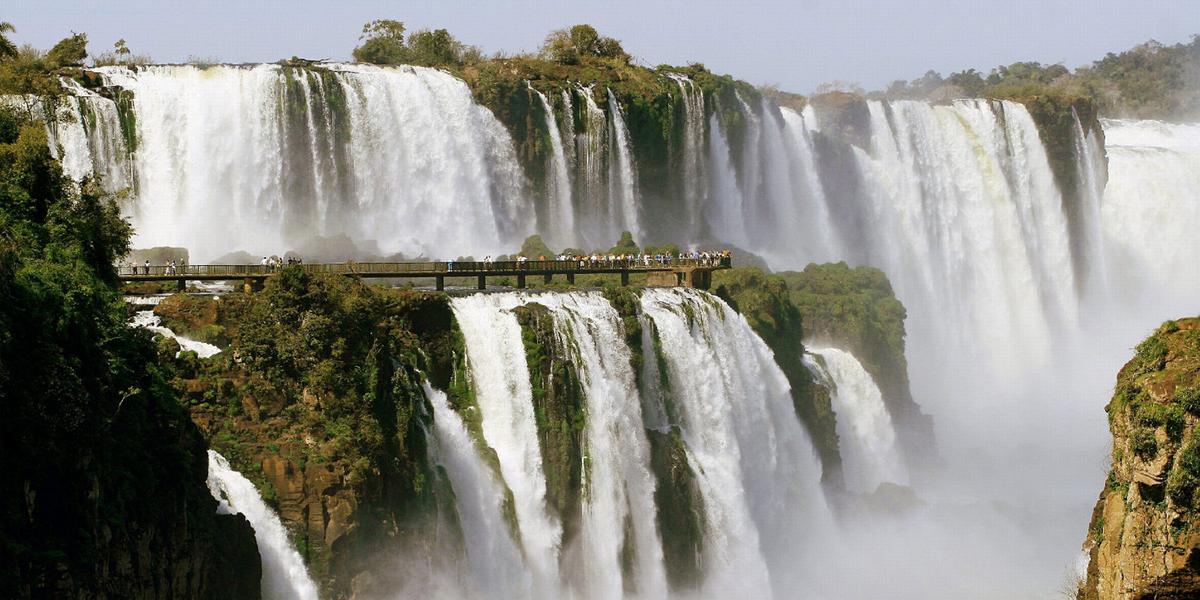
88,65,532,262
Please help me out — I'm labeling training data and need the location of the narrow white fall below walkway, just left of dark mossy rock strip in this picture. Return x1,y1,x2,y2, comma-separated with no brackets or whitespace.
451,294,563,596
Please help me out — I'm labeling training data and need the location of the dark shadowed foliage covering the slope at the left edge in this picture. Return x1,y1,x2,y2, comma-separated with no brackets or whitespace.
0,97,251,598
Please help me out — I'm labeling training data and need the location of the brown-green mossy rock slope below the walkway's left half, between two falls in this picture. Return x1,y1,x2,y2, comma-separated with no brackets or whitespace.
184,269,462,598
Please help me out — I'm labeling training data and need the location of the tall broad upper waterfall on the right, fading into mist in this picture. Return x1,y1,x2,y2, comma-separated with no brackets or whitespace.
854,101,1075,379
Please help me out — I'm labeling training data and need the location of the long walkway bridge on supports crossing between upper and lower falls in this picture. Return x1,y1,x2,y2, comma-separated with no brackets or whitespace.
118,257,732,293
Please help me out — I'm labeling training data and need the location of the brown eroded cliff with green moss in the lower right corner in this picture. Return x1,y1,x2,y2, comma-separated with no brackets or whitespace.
1078,318,1200,600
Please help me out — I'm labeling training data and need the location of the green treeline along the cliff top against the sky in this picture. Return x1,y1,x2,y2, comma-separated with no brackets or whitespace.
0,19,1200,120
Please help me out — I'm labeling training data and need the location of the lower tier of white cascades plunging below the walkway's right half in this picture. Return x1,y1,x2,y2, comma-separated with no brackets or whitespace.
441,289,832,599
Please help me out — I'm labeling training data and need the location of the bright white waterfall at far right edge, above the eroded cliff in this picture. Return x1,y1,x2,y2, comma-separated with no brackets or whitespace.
1100,120,1200,307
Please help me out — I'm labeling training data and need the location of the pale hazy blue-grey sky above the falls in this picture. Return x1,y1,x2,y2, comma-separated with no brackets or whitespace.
0,0,1200,92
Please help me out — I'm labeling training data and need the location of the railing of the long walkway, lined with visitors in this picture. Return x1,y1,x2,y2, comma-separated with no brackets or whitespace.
118,257,731,280
